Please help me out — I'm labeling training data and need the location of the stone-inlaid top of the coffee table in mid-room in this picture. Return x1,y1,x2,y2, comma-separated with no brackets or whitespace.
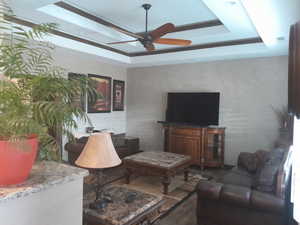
123,152,191,168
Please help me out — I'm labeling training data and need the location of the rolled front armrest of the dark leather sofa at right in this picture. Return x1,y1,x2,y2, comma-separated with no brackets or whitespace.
197,181,284,213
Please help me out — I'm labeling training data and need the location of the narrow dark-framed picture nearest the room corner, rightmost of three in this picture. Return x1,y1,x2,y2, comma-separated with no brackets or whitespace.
113,80,125,111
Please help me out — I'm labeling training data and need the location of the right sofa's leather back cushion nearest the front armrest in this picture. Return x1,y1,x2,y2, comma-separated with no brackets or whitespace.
254,148,285,193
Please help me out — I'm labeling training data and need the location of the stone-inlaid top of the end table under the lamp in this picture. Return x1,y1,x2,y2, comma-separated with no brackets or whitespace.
84,185,163,225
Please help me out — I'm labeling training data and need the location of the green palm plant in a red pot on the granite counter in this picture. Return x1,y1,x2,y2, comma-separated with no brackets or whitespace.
0,5,99,185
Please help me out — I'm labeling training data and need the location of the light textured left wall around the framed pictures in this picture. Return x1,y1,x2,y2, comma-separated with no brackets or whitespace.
53,47,127,135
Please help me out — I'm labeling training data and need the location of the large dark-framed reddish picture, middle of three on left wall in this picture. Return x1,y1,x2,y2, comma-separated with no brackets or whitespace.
88,74,111,113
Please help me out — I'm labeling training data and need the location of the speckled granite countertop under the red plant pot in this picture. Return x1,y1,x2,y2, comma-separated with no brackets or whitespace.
0,161,89,203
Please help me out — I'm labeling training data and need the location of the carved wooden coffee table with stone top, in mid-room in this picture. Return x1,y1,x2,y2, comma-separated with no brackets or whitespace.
123,152,191,194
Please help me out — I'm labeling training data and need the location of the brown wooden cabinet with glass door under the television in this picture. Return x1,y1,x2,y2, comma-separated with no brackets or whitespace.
159,122,225,169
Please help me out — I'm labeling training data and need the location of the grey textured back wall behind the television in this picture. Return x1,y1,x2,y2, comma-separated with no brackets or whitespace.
127,56,288,164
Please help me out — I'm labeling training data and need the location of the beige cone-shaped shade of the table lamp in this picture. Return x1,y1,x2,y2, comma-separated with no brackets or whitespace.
75,133,121,169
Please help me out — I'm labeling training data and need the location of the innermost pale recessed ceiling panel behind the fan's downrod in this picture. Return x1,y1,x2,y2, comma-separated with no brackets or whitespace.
65,0,217,32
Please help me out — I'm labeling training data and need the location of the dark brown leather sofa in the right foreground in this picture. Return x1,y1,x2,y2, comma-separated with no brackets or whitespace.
197,147,292,225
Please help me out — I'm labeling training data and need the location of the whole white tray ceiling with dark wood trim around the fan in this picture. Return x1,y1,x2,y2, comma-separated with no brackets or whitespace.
8,0,300,66
